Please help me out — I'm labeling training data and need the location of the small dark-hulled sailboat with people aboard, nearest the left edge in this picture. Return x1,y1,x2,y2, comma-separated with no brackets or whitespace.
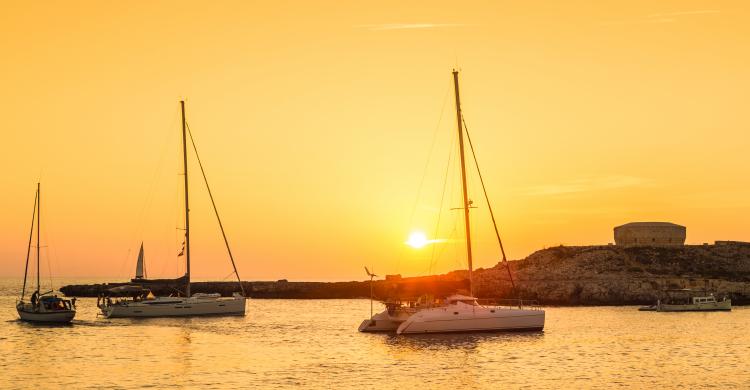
16,183,76,324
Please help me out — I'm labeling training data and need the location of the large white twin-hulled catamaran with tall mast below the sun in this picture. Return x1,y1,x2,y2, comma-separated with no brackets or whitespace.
359,70,545,334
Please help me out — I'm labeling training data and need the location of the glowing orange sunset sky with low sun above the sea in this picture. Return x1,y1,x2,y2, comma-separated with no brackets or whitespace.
0,1,750,280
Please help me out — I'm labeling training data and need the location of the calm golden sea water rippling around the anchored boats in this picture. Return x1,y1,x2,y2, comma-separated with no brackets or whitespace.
0,280,750,389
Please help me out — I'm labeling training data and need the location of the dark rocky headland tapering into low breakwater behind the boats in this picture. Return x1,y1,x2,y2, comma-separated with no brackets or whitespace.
60,242,750,305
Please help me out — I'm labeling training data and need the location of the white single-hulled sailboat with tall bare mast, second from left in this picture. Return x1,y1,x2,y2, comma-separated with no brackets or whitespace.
98,101,247,318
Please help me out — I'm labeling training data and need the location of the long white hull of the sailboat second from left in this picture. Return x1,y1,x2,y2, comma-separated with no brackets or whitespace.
100,297,246,318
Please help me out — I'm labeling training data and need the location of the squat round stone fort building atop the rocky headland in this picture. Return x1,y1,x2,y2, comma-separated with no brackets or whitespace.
615,222,687,246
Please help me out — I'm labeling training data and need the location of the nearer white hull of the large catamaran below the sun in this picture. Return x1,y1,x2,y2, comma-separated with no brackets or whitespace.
396,304,544,334
